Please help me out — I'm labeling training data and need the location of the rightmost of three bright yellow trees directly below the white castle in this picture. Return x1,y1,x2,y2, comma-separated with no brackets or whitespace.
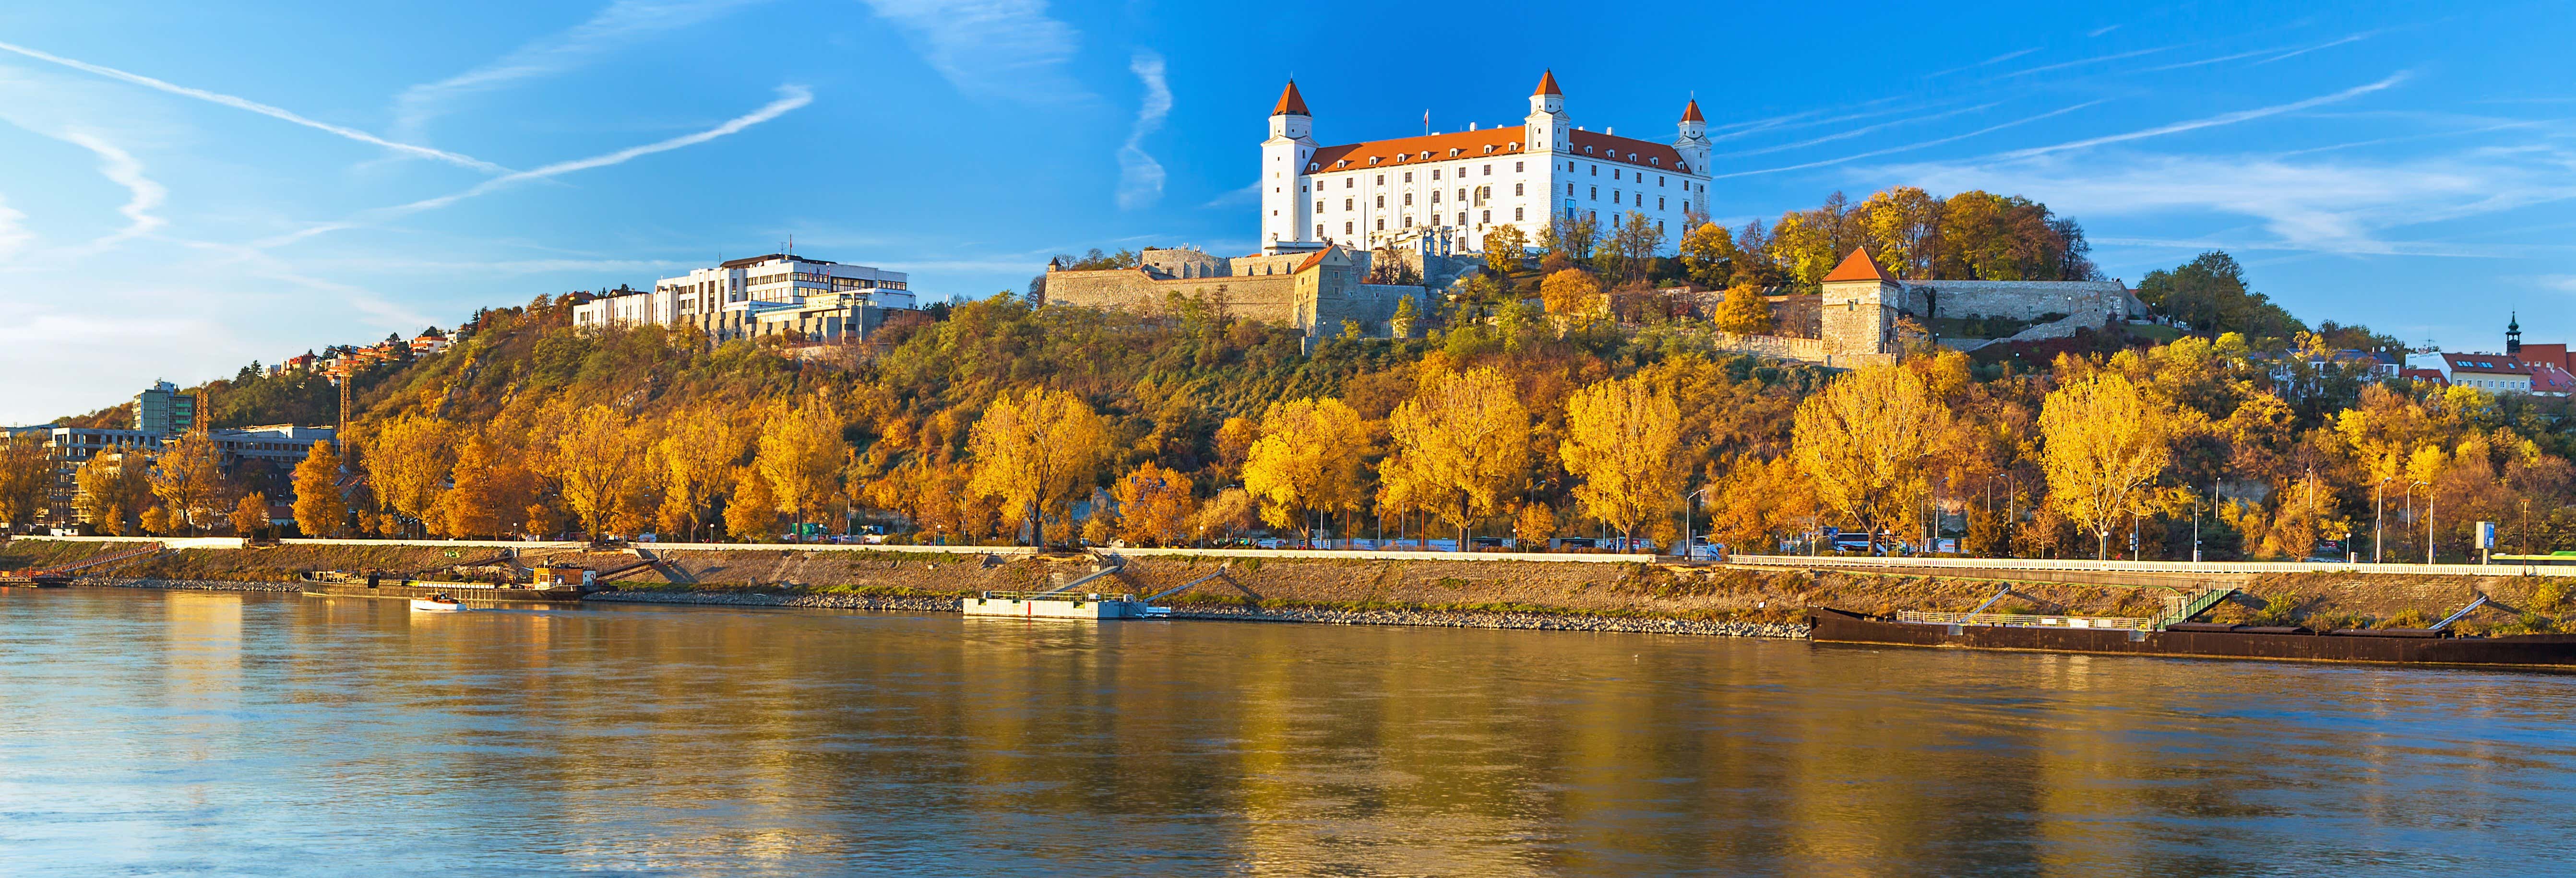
1561,379,1682,546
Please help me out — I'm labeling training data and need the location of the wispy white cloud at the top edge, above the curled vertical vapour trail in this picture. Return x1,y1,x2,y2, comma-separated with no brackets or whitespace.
868,0,1087,100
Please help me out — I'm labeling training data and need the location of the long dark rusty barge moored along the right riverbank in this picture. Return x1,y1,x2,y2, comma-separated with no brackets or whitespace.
1808,600,2576,667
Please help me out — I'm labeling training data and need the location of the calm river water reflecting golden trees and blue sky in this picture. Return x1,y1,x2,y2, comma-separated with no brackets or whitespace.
0,590,2576,876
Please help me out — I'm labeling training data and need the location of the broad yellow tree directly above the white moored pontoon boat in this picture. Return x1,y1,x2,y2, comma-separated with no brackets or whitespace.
966,389,1108,541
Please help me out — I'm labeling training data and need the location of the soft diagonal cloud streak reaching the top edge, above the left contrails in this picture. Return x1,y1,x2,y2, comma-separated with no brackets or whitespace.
394,0,760,136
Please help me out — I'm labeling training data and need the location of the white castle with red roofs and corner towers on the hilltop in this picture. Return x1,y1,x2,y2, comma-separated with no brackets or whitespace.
1260,72,1710,252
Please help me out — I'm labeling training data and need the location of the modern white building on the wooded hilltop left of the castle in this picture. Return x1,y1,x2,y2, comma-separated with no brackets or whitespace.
572,252,915,337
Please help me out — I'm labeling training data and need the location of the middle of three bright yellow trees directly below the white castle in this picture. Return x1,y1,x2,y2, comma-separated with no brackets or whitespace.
1378,368,1530,551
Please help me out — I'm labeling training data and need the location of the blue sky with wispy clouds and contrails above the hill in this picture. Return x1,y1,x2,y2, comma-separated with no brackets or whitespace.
0,0,2576,422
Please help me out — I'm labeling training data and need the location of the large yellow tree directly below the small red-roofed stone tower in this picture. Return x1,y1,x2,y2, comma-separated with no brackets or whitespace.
1790,363,1950,548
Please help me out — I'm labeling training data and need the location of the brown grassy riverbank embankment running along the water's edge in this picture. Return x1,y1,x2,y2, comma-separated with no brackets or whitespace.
0,541,2576,636
